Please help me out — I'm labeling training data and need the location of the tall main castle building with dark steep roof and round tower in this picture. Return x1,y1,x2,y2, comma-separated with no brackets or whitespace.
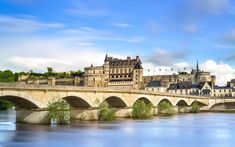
84,55,143,89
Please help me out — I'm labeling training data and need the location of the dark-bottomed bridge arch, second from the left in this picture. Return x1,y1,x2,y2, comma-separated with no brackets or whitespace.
62,96,92,109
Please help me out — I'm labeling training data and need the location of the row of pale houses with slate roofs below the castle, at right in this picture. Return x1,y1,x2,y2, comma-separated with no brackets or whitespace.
145,79,235,97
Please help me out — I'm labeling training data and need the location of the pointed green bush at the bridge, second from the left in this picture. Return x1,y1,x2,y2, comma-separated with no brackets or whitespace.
98,102,116,121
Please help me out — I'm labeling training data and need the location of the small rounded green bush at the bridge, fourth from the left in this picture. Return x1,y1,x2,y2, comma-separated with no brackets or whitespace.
158,101,175,115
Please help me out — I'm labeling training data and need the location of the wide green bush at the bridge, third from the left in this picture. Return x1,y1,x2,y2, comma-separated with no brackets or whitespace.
132,100,153,118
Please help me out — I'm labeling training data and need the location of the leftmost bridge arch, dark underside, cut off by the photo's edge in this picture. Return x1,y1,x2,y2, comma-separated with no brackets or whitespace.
0,91,41,109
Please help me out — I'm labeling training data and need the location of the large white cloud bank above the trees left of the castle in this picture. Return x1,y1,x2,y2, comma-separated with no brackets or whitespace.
0,38,123,72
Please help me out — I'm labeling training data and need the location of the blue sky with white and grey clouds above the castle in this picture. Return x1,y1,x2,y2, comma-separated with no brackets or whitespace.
0,0,235,85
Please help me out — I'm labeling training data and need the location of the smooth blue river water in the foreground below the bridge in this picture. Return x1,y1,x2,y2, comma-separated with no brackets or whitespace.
0,113,235,147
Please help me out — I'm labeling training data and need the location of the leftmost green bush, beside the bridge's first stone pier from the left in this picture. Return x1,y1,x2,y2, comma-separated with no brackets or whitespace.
48,100,70,124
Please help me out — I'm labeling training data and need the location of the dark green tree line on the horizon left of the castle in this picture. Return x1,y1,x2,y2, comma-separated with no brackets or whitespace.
0,67,84,82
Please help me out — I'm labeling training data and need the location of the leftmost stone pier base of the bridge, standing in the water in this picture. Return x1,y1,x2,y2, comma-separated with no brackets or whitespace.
16,109,48,124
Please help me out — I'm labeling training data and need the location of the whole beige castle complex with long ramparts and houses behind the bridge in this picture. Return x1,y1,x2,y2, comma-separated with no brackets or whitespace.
19,54,235,97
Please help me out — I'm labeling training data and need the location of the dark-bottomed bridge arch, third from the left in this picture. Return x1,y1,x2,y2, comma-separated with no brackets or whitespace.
100,96,128,108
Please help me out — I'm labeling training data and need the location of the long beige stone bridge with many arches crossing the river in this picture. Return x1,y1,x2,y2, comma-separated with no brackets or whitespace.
0,83,235,123
